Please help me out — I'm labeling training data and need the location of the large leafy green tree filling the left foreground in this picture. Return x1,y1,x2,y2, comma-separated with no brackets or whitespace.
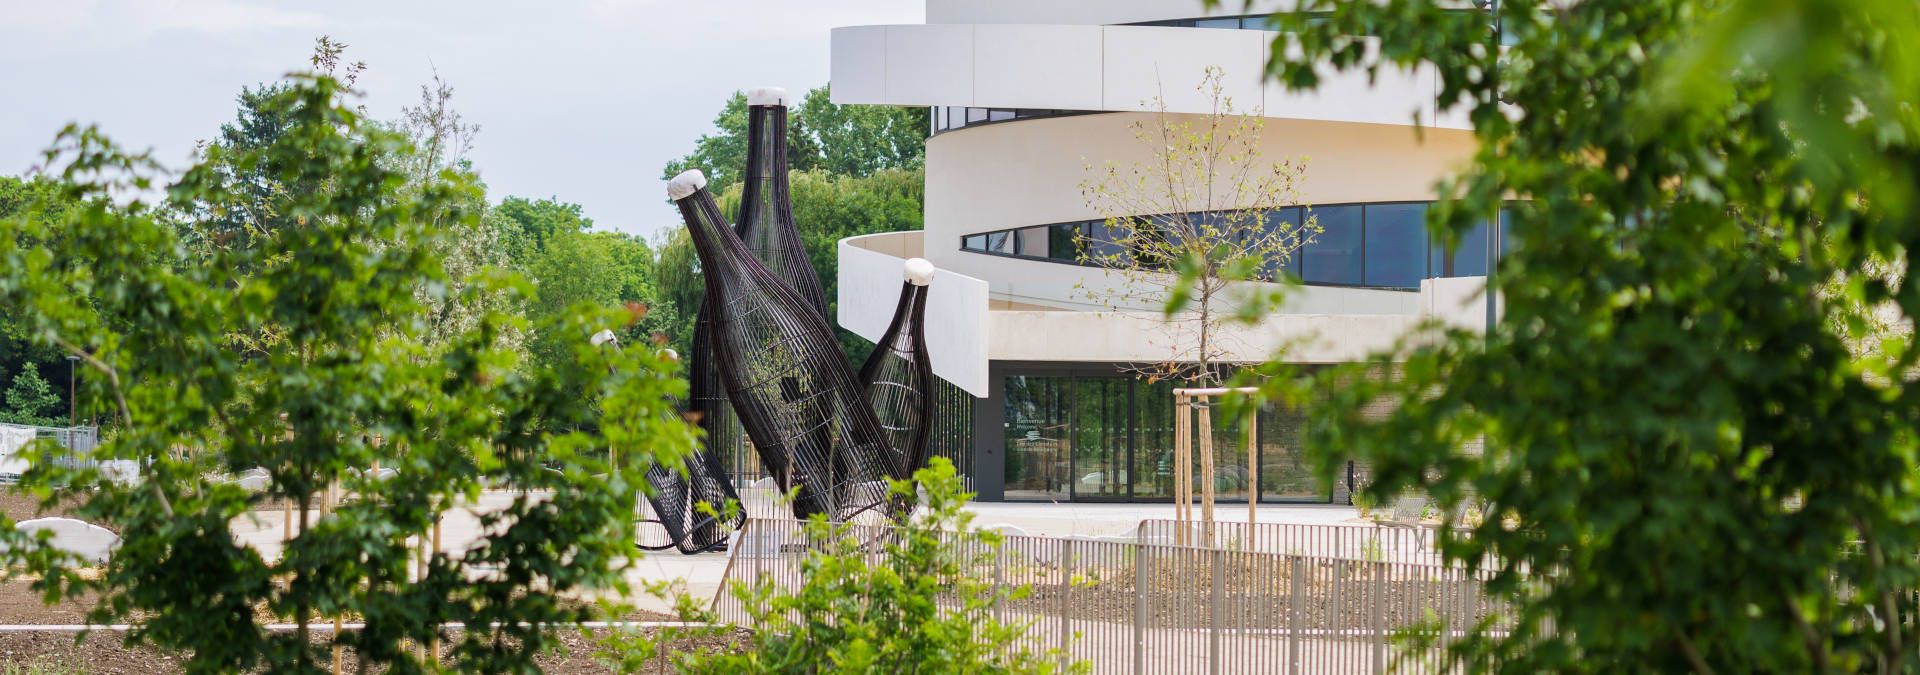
0,75,695,673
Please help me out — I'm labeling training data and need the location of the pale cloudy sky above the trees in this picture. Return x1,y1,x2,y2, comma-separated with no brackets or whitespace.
0,0,924,236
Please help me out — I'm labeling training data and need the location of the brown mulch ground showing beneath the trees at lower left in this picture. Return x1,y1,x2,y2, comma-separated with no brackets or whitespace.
0,485,741,675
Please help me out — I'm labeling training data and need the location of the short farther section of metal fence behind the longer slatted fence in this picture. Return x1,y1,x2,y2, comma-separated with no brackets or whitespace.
1137,520,1442,564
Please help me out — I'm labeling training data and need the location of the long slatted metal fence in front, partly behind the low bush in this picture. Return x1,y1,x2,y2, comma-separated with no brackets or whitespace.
714,520,1500,673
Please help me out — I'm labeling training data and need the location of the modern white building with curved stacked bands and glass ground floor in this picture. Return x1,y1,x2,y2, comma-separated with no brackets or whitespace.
833,0,1486,500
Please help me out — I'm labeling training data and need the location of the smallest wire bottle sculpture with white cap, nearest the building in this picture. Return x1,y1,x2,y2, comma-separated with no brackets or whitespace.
860,257,933,472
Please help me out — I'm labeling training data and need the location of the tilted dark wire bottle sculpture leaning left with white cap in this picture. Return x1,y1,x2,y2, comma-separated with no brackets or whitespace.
666,171,908,520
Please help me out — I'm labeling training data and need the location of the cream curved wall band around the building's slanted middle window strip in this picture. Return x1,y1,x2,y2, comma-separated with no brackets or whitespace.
925,113,1475,314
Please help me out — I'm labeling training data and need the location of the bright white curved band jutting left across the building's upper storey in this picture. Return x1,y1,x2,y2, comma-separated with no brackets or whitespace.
833,23,1469,128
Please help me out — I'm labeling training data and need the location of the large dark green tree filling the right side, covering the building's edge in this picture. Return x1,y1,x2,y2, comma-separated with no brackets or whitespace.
1221,0,1920,673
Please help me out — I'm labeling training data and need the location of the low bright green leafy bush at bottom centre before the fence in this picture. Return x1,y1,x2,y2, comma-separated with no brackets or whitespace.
603,458,1089,675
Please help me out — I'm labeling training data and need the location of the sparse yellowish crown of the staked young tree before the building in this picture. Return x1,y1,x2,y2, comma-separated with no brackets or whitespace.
1073,67,1319,387
